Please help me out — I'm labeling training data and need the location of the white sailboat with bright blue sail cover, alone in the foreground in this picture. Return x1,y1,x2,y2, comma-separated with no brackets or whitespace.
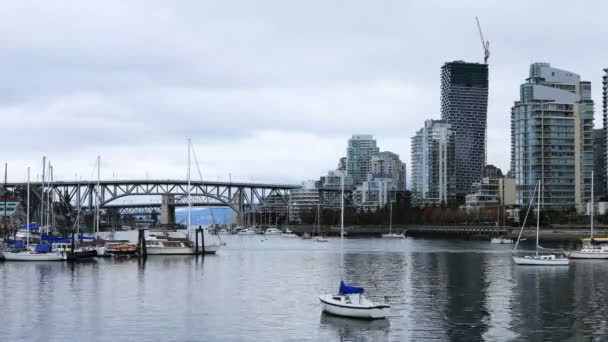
319,175,390,319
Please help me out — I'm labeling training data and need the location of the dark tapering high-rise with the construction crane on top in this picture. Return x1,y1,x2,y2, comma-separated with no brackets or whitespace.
441,61,488,200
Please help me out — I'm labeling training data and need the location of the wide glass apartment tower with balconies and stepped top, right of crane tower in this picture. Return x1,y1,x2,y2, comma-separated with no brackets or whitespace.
511,63,593,211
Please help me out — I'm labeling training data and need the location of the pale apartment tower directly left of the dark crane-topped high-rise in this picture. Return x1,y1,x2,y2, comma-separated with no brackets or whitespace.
412,120,456,206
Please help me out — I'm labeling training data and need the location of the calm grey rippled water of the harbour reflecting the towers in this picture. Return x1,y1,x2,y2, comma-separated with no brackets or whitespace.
0,236,608,342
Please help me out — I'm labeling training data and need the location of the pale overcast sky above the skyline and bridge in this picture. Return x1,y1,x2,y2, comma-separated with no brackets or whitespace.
0,0,608,184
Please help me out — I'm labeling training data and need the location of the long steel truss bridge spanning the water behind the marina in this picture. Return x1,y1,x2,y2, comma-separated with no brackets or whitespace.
6,180,300,214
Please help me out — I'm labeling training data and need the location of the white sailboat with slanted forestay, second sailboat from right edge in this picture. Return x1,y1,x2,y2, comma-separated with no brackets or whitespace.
513,181,570,266
